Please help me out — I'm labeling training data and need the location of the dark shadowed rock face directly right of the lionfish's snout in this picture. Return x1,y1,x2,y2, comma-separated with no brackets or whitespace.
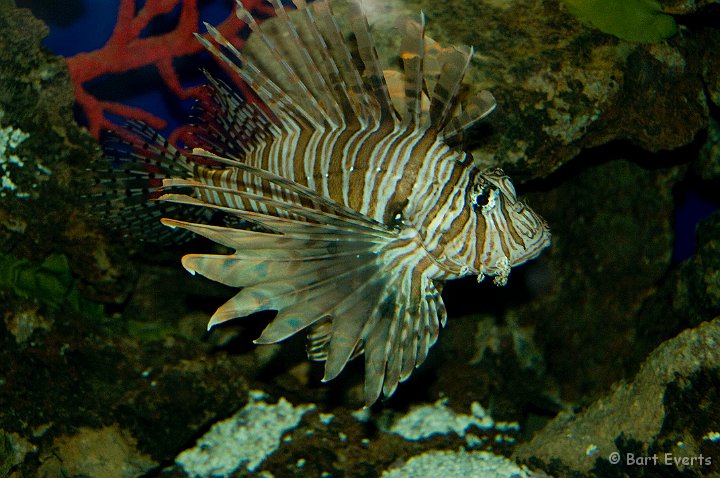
514,160,679,401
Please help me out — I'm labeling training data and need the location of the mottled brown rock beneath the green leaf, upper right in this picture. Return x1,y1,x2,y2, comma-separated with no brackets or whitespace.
374,0,717,180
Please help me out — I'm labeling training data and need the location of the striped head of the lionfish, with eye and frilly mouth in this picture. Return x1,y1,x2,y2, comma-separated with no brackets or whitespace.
467,169,550,285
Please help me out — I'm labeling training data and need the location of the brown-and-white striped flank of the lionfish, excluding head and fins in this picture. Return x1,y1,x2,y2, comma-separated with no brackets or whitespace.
195,121,456,230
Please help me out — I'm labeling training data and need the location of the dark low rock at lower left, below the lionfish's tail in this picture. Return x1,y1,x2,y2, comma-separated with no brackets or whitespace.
0,301,254,476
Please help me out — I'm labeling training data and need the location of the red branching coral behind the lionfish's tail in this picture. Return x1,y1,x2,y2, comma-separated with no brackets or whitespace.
67,0,270,138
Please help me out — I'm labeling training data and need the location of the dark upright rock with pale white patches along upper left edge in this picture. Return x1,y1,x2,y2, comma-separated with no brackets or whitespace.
0,2,133,303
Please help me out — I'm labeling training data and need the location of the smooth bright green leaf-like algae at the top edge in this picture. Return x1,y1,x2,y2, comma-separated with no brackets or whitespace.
563,0,677,43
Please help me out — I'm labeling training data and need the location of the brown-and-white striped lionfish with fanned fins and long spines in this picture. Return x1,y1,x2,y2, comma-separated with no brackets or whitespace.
93,0,550,405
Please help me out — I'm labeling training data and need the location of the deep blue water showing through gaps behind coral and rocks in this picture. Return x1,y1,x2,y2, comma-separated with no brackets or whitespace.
17,0,720,263
